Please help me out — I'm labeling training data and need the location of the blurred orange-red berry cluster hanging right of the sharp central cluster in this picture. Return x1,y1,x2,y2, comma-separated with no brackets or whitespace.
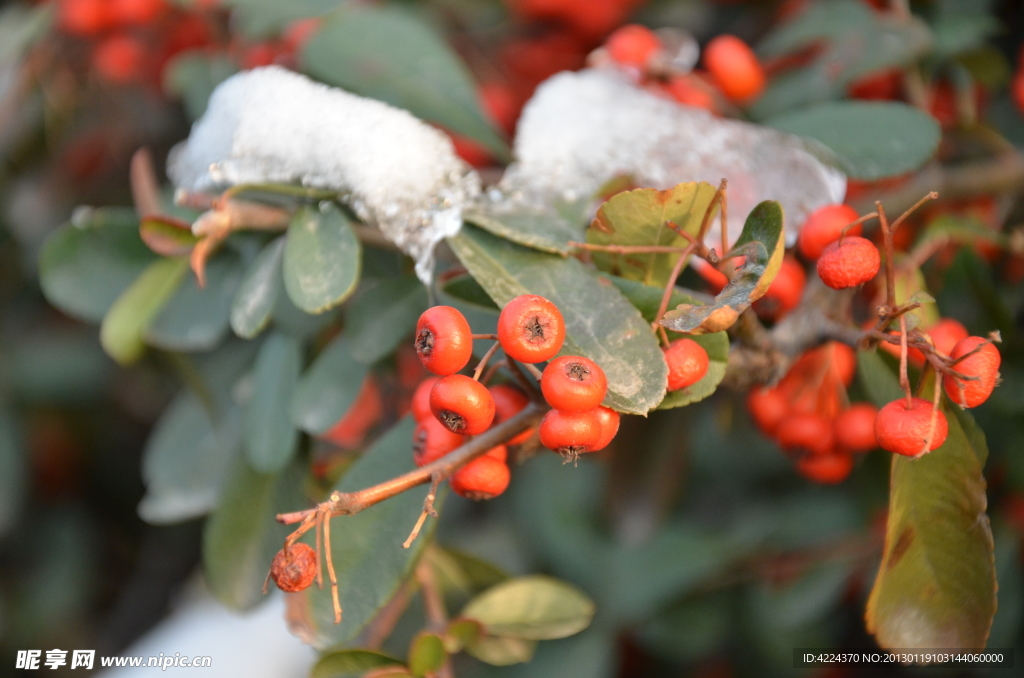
746,342,878,483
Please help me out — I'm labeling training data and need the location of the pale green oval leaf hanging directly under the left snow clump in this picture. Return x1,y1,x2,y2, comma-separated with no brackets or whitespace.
285,203,362,313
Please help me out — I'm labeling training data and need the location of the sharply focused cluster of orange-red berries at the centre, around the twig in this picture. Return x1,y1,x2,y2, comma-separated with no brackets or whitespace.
412,295,618,499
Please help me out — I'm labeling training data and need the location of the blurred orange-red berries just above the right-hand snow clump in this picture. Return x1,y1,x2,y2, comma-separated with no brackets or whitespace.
604,24,765,112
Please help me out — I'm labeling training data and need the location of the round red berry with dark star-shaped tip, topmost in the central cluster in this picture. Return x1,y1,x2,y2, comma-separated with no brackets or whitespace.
498,294,565,363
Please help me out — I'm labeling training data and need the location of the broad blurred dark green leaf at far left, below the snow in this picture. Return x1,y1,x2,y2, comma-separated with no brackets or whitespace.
39,208,157,323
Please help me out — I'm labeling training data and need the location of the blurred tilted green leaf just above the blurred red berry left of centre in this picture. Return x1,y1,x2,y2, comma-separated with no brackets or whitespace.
291,335,368,435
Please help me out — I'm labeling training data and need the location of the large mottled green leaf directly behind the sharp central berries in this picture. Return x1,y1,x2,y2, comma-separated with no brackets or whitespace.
447,225,668,414
